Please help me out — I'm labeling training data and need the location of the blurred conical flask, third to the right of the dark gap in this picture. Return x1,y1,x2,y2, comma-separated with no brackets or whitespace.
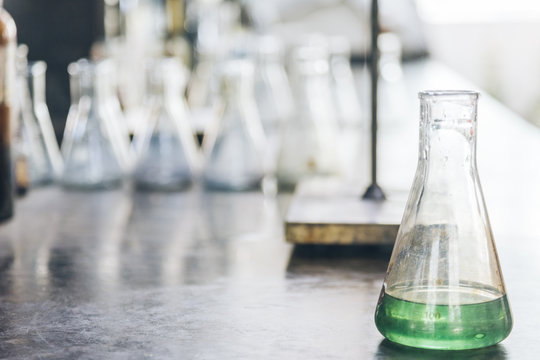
203,60,265,190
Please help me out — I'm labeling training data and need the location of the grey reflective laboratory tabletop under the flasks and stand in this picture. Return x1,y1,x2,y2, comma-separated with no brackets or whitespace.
0,61,540,360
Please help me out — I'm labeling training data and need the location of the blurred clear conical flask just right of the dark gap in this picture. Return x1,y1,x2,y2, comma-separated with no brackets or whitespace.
62,60,127,189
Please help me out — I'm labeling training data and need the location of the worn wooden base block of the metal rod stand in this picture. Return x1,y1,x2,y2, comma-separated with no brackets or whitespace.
285,178,408,245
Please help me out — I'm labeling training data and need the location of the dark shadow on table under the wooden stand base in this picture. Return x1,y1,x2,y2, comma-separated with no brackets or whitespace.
287,245,392,275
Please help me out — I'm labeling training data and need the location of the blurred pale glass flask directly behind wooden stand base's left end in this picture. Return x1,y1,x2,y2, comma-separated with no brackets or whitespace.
276,44,339,189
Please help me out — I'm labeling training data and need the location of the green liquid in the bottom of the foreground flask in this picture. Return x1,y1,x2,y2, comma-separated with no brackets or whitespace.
375,293,512,350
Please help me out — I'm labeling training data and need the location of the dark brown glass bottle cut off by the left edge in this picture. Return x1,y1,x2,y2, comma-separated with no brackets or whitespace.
0,0,17,221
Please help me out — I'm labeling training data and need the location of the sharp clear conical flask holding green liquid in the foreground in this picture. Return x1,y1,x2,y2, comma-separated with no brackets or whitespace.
375,91,512,350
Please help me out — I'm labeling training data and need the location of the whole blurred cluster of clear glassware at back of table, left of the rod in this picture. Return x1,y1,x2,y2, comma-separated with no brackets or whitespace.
5,1,362,193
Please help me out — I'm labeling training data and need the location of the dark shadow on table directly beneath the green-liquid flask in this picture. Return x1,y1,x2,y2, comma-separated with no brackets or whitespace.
374,339,507,360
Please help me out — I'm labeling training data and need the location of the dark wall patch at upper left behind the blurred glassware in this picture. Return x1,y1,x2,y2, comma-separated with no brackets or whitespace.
4,0,104,143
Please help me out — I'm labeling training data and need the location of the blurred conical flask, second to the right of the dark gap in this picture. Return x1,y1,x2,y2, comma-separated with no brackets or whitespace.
133,58,198,190
